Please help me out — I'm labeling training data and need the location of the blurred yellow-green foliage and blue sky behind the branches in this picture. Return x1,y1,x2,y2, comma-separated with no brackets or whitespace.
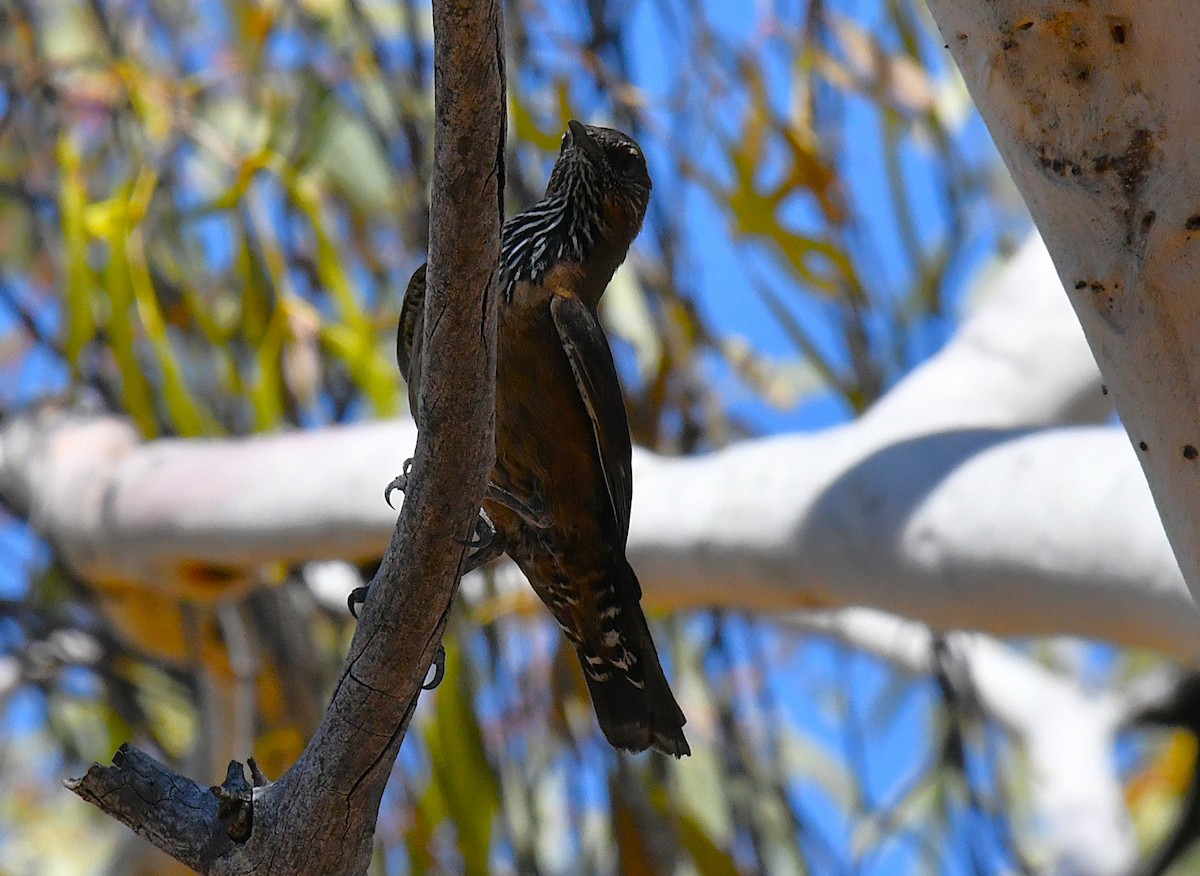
0,0,1180,875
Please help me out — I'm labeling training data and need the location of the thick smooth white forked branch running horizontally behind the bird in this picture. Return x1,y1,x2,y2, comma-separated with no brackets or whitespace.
7,235,1200,661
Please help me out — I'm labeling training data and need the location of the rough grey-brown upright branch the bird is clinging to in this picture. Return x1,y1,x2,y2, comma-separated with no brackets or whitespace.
67,0,505,875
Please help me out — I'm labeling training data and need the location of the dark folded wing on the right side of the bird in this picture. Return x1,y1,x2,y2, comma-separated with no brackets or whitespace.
550,295,634,545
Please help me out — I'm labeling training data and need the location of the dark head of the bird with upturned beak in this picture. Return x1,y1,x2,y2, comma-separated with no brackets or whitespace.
546,119,652,245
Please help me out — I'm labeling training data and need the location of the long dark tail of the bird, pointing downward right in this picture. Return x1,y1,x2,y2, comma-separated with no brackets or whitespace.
578,563,691,757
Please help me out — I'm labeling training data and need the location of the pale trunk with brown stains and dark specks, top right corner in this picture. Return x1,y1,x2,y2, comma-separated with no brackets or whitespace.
928,0,1200,607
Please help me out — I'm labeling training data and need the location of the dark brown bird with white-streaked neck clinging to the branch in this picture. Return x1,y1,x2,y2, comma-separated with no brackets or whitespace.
396,119,691,757
